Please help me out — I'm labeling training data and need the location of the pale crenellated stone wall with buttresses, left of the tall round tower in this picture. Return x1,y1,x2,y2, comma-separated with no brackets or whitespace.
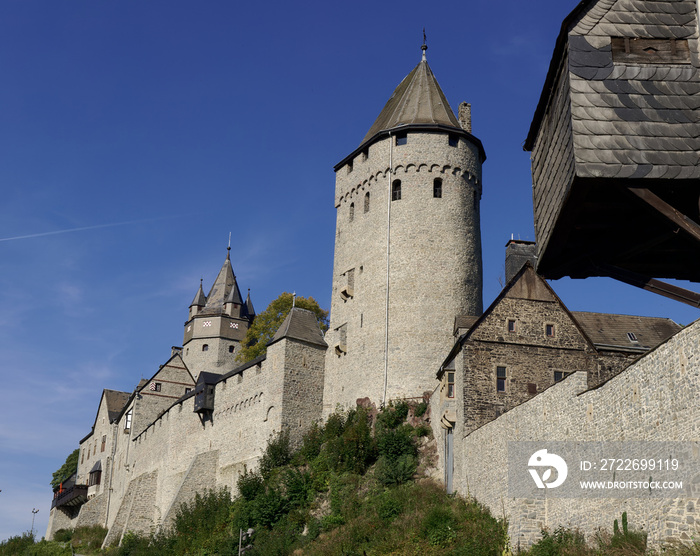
70,332,325,545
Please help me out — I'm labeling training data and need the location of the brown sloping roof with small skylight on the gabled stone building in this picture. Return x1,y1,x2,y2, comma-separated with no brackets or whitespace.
572,311,683,351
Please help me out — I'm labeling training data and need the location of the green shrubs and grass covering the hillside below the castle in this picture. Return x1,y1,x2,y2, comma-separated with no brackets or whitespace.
5,402,700,556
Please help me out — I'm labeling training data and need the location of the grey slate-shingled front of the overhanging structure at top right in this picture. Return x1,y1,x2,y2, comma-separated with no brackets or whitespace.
525,0,700,179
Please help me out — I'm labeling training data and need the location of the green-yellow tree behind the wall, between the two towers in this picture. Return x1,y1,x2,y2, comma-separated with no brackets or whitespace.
236,292,328,363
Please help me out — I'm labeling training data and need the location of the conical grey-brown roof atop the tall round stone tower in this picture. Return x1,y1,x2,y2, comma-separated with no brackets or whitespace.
361,55,462,144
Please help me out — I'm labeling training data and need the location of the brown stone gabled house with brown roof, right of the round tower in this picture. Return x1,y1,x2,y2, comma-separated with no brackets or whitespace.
431,261,682,492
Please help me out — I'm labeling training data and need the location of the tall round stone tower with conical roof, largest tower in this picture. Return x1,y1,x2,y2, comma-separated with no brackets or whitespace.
324,45,485,414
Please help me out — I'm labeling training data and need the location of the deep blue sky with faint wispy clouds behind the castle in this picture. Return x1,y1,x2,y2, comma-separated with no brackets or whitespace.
0,0,699,539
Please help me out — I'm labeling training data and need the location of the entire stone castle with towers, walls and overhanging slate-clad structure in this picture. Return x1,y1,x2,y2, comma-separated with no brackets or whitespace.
47,0,700,544
